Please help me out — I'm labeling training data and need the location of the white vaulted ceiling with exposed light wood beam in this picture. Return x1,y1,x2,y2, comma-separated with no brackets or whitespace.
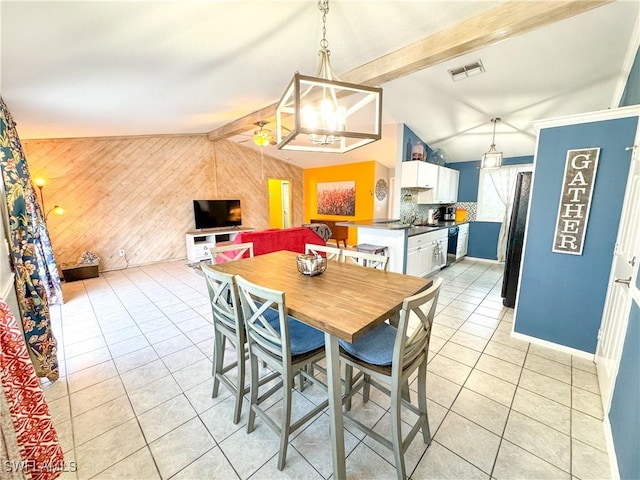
0,0,640,167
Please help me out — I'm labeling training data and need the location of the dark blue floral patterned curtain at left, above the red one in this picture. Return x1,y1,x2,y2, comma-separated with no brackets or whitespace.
0,97,62,381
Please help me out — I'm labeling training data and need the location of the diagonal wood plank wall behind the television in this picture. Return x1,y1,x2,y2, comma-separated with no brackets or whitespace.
22,135,303,271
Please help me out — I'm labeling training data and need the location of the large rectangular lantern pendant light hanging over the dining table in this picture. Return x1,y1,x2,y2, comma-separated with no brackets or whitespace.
276,0,382,153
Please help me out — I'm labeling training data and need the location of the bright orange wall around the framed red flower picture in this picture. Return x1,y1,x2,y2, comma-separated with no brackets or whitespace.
303,161,376,245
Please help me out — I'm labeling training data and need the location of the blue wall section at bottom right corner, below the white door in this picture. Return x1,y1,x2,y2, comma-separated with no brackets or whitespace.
609,302,640,480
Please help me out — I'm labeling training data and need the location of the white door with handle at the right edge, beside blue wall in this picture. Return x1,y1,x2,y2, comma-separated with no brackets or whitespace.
596,141,640,415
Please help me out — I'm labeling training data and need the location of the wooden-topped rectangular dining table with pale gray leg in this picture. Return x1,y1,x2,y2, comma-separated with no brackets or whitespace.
213,250,432,479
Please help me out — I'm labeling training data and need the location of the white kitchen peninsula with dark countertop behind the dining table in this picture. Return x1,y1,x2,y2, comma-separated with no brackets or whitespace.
336,219,466,277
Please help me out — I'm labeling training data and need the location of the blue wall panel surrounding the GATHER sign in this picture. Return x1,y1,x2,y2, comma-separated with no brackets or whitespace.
514,117,638,353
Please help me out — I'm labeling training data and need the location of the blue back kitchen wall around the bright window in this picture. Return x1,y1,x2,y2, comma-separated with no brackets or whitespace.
447,155,533,260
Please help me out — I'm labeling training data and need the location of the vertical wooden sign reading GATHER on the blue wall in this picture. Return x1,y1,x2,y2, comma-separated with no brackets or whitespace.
552,148,600,255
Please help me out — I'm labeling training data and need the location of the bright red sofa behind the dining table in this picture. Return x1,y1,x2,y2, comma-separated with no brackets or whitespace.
233,227,327,258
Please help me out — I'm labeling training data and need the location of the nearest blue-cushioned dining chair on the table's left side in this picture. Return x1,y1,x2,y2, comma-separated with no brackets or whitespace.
236,275,328,470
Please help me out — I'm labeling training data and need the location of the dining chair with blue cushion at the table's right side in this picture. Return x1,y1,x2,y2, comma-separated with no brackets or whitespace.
340,278,442,480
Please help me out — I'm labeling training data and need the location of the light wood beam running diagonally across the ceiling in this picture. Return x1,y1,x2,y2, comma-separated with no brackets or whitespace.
207,0,613,141
